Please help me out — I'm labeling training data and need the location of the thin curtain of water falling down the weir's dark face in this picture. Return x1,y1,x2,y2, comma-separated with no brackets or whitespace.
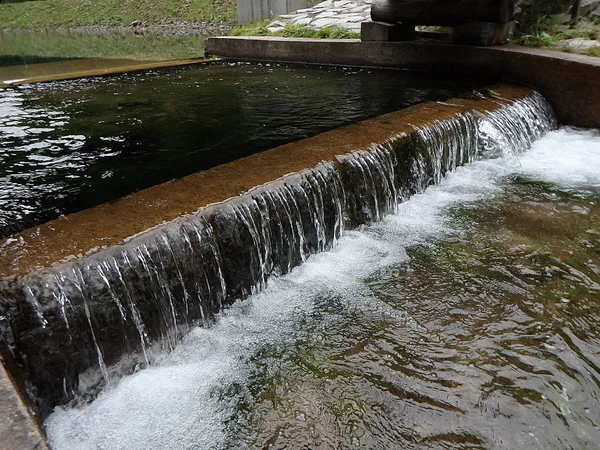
0,89,556,417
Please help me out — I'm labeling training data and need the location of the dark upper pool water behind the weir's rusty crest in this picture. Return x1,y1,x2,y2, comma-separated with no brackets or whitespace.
0,63,489,236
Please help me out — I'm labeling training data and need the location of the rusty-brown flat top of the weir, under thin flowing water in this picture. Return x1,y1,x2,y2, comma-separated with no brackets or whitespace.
0,86,531,280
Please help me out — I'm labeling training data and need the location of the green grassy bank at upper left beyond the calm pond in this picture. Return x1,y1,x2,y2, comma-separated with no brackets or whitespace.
0,0,236,30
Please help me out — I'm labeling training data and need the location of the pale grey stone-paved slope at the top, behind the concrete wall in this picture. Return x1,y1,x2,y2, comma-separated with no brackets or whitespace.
267,0,371,32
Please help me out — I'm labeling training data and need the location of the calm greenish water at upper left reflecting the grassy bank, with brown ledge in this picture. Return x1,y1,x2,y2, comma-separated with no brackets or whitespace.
0,28,211,88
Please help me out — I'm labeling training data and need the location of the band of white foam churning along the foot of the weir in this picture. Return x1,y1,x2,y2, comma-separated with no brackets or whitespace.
46,129,600,450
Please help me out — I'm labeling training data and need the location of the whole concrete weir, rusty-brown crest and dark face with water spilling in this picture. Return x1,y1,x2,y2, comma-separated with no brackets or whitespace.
0,85,554,448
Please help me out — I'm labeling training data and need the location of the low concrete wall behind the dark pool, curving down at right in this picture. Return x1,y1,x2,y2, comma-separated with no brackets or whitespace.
205,37,600,128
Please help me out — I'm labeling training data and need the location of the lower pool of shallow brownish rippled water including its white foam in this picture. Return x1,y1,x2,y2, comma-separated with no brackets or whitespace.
46,129,600,449
